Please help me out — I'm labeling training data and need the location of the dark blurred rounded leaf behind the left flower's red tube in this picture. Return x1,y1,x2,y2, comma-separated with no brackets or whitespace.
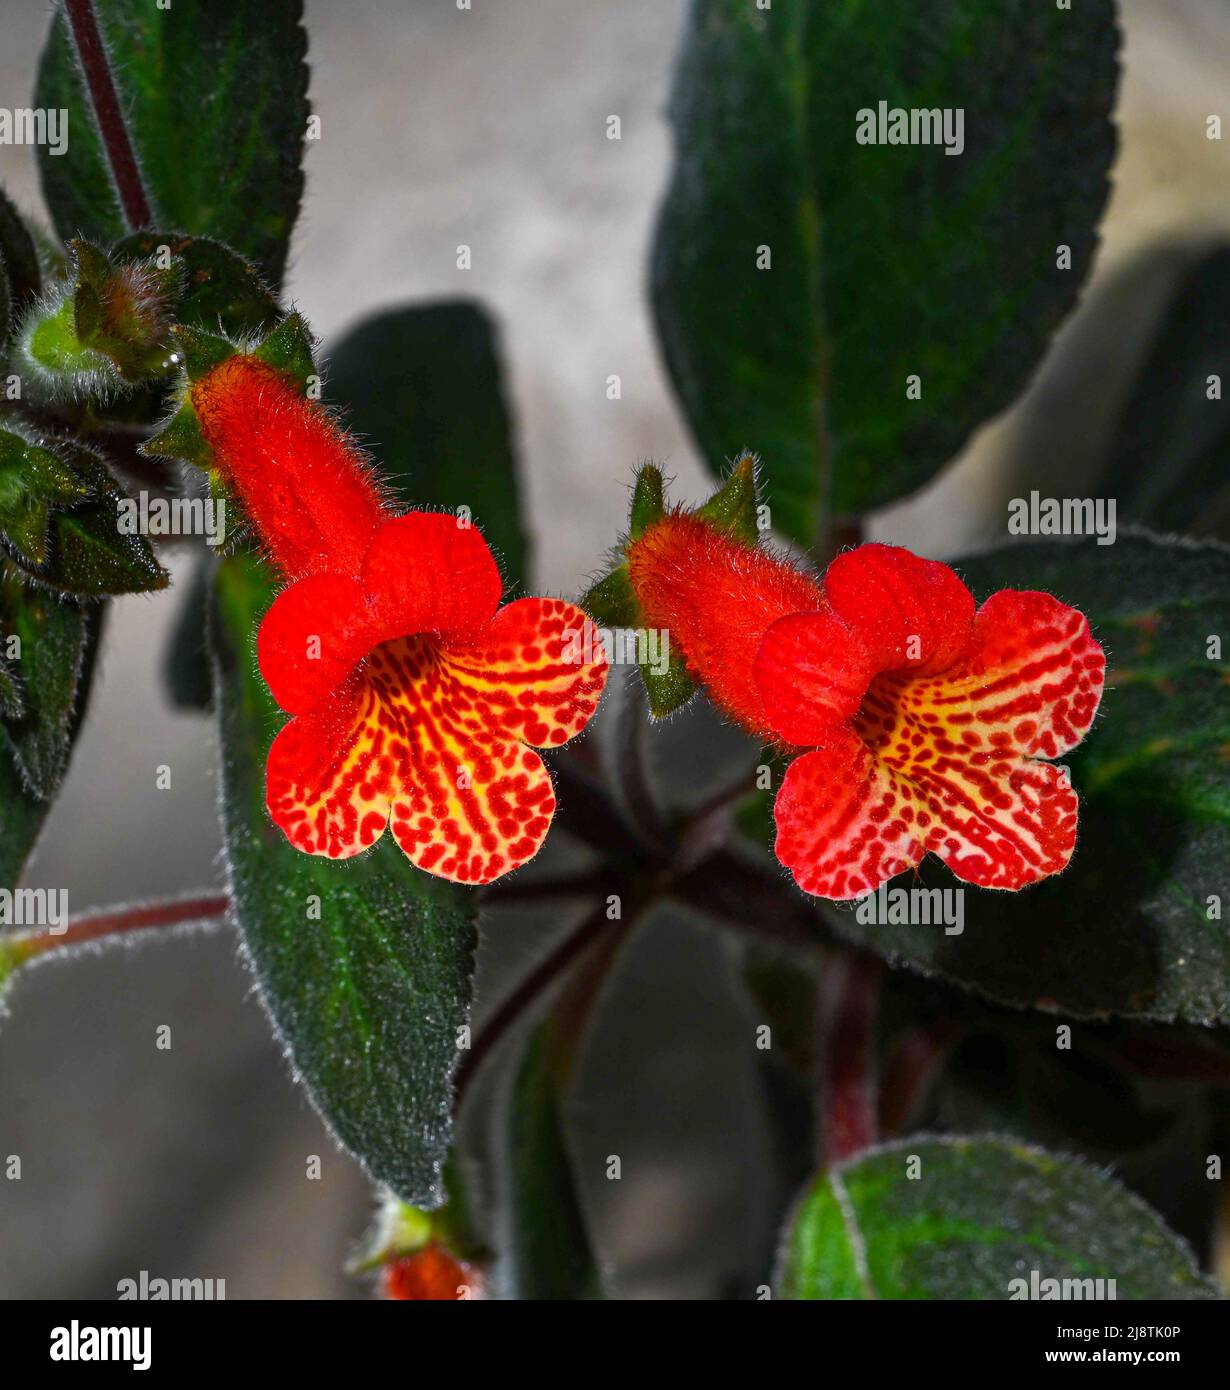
327,300,530,582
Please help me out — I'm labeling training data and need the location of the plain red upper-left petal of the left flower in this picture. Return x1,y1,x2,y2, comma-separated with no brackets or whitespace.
256,574,375,714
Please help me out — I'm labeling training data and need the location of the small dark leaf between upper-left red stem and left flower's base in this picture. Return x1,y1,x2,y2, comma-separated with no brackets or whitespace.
111,232,279,336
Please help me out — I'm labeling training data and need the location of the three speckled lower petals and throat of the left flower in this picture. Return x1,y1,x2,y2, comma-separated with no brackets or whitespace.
268,599,606,884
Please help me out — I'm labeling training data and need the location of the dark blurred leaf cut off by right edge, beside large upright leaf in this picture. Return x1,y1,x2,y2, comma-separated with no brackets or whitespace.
1097,245,1230,535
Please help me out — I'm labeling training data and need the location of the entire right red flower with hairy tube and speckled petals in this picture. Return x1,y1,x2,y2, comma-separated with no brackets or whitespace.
627,514,1106,899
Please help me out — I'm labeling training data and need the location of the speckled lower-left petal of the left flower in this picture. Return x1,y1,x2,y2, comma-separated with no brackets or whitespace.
265,674,396,859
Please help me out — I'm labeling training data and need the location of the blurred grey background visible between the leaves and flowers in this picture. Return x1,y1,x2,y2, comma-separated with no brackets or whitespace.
0,0,1230,1298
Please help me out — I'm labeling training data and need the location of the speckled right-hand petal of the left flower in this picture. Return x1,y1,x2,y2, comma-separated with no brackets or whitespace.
442,598,607,748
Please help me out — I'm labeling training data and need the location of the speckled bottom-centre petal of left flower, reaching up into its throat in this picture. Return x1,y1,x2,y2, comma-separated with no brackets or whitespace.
364,637,555,884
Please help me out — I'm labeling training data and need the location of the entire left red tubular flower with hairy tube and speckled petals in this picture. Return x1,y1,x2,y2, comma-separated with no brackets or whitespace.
190,356,606,884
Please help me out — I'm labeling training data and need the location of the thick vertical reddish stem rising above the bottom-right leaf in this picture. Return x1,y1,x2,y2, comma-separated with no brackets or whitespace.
817,952,880,1165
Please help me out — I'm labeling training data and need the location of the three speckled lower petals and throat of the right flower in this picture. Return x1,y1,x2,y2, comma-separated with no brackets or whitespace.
776,591,1105,898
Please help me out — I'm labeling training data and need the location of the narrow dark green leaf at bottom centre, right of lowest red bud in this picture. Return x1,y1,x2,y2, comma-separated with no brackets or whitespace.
507,1019,602,1300
